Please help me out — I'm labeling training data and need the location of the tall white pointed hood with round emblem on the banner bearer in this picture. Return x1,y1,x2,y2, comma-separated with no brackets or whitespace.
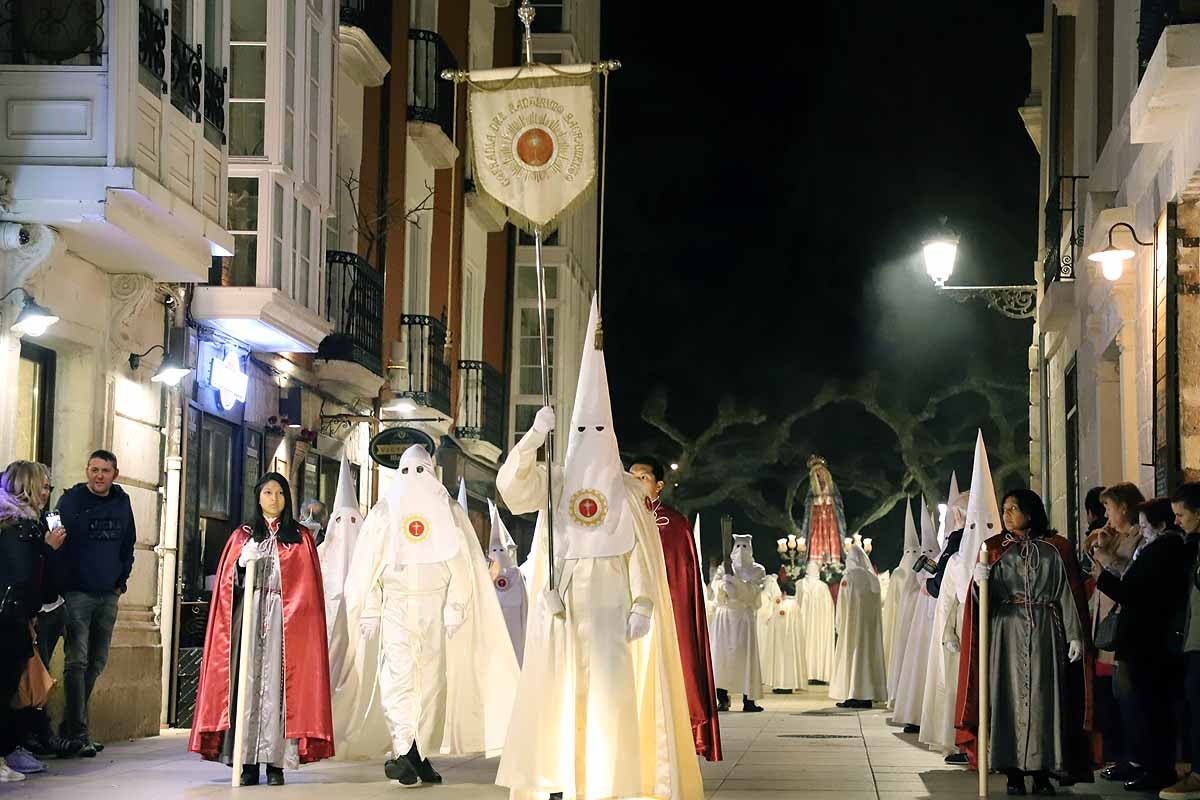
554,296,634,559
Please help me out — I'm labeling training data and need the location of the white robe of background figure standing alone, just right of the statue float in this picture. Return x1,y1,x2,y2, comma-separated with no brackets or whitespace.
829,570,888,700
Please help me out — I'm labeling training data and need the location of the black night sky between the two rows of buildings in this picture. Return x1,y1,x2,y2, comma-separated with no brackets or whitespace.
601,0,1042,569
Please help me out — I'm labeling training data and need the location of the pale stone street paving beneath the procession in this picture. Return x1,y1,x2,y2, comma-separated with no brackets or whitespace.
0,687,1123,800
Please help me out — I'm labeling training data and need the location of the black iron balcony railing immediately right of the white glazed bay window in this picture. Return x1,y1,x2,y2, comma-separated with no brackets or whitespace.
317,249,384,377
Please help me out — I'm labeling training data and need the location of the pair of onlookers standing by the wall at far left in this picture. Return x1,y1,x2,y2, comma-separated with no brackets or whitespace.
0,450,137,782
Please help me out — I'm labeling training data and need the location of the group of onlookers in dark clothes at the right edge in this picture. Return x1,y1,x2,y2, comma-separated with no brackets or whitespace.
1080,483,1200,800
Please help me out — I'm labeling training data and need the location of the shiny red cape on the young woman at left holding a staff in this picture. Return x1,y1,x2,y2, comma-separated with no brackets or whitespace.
187,525,334,764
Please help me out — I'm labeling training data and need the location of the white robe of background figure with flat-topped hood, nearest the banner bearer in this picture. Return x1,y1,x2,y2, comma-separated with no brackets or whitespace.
710,566,766,700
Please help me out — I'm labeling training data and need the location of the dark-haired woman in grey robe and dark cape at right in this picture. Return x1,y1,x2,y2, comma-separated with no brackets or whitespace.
974,489,1091,795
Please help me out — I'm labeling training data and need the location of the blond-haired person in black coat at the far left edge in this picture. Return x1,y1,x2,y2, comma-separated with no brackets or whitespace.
0,461,65,782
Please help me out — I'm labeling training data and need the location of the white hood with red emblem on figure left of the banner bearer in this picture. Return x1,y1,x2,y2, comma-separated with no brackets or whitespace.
388,445,458,566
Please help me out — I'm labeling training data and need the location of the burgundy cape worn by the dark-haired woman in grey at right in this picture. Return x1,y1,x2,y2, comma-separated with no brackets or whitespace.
954,534,1096,786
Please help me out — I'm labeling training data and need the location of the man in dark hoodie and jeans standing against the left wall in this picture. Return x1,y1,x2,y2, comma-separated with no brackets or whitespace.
56,450,137,756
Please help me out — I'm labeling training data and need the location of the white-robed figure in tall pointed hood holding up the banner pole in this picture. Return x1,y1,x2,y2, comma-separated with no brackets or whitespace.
496,299,703,800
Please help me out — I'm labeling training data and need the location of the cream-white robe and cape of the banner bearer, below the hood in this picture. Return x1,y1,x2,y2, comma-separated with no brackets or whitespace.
496,434,703,800
